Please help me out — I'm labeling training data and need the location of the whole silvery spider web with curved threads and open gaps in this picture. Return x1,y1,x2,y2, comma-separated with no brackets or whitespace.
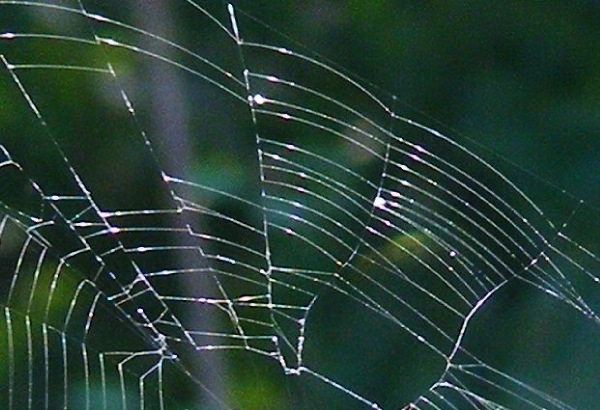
0,1,600,409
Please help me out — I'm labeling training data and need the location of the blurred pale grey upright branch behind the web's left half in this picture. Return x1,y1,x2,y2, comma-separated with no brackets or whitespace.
134,0,224,409
